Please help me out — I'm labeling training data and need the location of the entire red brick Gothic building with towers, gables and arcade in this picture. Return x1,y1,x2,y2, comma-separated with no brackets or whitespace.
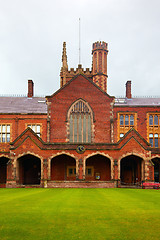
0,42,160,187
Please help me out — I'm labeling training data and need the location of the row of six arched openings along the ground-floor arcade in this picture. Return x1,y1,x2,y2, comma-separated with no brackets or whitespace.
0,154,160,186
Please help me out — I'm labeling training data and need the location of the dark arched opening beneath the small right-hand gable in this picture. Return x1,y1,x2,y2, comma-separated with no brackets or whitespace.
120,155,143,185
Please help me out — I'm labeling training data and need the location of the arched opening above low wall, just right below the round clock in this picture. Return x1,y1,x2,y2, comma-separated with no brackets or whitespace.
85,154,111,181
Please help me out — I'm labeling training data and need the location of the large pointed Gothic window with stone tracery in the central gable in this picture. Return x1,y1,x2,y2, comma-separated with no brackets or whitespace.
68,100,93,143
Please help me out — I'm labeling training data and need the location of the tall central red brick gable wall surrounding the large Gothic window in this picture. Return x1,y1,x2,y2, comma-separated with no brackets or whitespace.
46,74,114,142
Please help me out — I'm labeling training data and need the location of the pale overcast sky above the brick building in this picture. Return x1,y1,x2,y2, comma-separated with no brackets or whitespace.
0,0,160,96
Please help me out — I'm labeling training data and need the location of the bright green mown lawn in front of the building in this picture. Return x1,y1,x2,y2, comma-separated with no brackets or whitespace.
0,189,160,240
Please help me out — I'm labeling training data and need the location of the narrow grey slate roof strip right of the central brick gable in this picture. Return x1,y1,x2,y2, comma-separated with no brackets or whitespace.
114,97,160,107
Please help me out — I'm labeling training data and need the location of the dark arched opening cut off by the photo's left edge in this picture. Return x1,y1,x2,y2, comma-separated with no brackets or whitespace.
0,157,9,186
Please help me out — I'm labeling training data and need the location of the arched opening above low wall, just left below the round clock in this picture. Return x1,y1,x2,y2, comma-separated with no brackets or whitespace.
51,154,76,181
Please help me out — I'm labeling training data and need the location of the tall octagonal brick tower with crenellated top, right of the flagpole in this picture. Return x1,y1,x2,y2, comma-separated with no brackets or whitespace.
92,42,108,92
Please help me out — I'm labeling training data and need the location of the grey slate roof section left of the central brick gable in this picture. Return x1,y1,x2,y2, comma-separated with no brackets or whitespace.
0,97,47,114
